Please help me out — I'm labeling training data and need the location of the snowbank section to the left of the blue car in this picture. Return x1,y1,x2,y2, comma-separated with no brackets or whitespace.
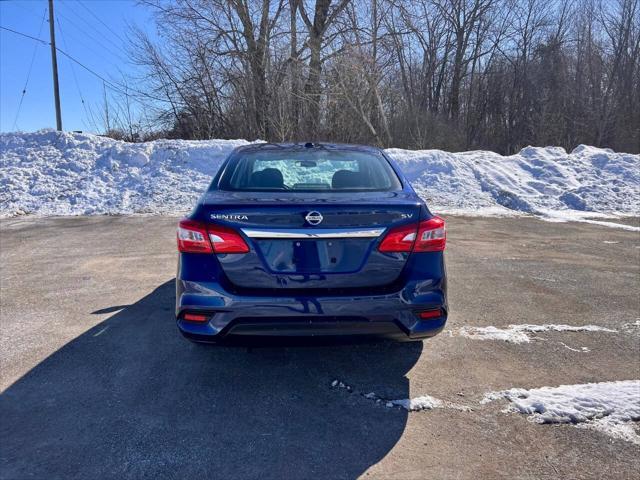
0,131,248,216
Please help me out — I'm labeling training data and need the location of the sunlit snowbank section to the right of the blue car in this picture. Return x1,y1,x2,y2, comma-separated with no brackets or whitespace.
387,145,640,214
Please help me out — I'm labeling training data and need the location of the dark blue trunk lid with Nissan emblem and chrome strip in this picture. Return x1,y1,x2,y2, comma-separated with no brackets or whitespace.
192,192,422,290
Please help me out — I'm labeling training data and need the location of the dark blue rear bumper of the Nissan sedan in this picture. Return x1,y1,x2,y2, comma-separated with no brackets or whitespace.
176,279,447,343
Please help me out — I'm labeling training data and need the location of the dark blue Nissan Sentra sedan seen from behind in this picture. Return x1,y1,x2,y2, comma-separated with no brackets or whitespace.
176,143,448,343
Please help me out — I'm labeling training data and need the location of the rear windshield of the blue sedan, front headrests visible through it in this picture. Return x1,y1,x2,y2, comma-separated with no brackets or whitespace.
219,148,402,192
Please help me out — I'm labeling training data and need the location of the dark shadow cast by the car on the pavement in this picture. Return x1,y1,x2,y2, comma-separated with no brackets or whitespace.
0,281,422,479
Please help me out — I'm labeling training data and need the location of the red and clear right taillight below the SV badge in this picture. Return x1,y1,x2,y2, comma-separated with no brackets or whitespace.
378,217,447,252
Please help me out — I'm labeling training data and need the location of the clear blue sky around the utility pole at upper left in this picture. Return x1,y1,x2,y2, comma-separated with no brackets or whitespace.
0,0,154,132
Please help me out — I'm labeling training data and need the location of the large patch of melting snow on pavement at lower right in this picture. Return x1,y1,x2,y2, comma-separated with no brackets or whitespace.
482,380,640,444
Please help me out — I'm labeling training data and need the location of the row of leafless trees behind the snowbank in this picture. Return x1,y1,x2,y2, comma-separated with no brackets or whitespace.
122,0,640,153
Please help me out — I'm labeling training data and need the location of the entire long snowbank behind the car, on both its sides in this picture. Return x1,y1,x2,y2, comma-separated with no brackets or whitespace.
0,130,640,217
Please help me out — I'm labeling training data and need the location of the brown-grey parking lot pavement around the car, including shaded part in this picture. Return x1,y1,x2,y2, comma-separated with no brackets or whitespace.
0,216,640,479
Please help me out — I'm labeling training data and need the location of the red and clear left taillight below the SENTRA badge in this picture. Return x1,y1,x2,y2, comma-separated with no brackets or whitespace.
178,220,249,253
